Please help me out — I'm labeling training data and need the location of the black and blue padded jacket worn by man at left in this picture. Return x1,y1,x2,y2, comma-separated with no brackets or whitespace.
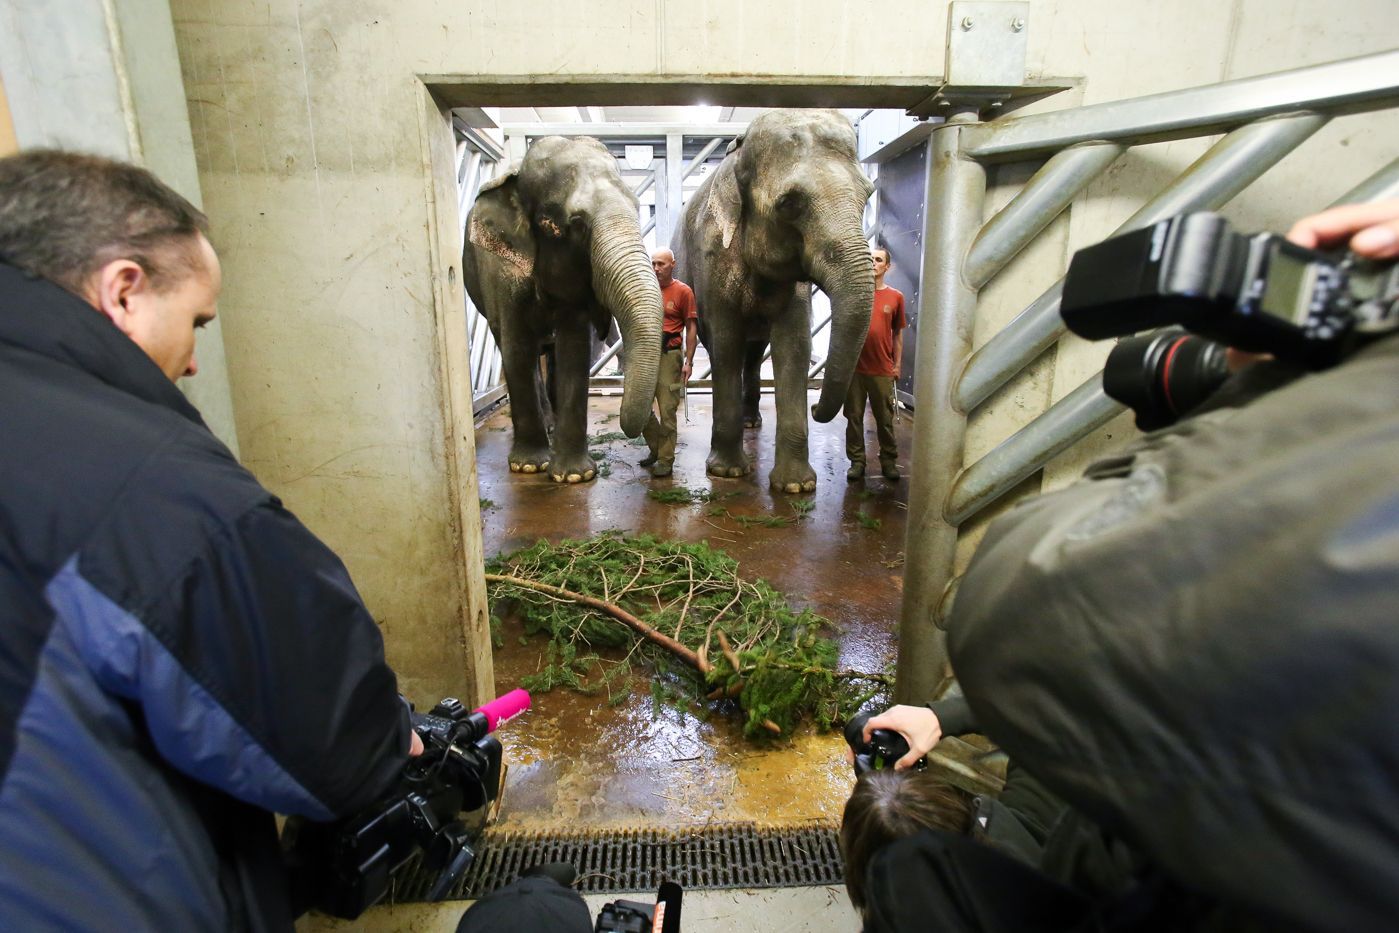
0,263,410,930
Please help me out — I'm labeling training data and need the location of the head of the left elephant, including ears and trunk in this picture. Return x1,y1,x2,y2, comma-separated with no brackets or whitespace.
469,136,663,436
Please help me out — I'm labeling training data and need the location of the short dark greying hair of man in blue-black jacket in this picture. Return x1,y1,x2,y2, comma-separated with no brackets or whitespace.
0,150,208,295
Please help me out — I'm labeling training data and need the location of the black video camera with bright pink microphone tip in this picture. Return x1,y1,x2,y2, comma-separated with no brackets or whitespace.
283,690,530,920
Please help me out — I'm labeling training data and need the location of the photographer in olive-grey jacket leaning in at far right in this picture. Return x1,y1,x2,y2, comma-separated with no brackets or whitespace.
870,201,1399,930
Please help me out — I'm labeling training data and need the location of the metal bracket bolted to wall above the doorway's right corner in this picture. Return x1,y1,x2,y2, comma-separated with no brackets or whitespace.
908,0,1072,117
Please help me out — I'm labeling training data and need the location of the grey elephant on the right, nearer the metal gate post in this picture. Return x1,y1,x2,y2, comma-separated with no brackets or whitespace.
674,111,874,492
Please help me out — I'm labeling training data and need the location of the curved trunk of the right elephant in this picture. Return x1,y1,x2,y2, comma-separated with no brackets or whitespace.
809,211,874,421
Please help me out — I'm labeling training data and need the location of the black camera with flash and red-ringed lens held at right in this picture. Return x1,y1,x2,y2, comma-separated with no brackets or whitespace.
1059,211,1399,431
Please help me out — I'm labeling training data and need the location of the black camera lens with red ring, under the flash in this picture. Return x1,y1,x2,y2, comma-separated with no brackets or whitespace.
1102,329,1230,431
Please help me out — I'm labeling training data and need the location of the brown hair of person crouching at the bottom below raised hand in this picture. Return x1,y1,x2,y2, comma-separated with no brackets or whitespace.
841,771,972,913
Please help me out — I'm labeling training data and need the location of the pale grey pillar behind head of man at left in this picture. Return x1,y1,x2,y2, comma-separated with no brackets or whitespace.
0,0,239,456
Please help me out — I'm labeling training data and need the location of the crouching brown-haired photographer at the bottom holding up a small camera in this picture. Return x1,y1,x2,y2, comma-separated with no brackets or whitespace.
841,697,1146,933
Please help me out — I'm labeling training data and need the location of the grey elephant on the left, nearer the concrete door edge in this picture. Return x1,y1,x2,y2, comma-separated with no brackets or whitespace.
462,136,663,483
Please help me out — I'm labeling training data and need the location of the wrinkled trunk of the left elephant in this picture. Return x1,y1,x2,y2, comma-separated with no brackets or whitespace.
592,211,665,438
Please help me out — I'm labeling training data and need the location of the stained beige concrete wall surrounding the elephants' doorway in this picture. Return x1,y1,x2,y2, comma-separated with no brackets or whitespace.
171,0,1393,699
